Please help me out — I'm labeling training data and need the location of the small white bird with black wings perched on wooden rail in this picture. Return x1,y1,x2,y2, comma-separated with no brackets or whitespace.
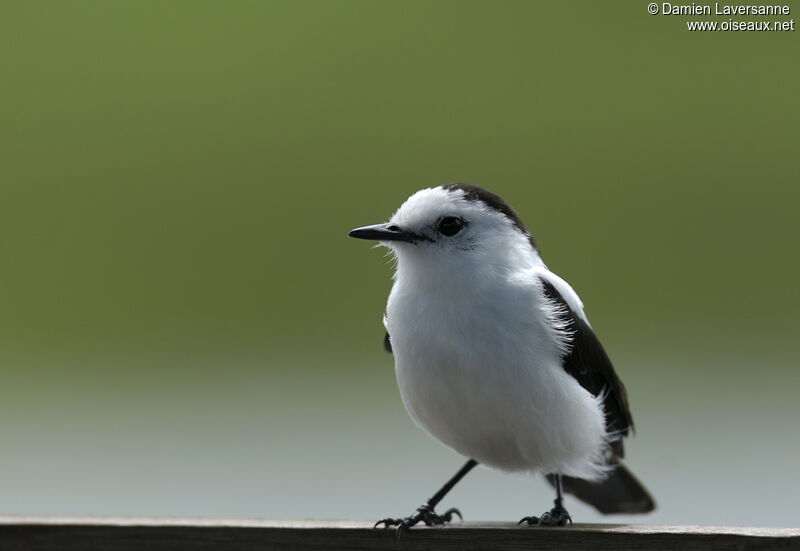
349,183,655,537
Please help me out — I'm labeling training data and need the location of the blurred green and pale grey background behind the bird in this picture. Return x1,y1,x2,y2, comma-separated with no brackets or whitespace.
0,0,800,526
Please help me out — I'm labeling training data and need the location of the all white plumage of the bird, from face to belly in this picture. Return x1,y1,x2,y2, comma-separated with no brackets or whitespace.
384,188,609,480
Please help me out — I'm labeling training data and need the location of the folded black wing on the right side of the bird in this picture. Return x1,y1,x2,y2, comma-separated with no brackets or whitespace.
541,278,633,457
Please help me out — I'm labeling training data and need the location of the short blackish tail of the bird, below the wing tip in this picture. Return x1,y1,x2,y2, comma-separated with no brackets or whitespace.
547,464,656,515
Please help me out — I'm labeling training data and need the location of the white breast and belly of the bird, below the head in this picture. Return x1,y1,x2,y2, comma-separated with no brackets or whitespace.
386,273,608,479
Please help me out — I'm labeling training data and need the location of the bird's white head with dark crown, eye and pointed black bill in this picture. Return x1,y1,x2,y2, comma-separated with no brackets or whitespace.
350,184,541,271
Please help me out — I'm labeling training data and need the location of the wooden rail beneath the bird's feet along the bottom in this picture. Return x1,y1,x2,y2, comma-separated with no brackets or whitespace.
0,516,800,551
